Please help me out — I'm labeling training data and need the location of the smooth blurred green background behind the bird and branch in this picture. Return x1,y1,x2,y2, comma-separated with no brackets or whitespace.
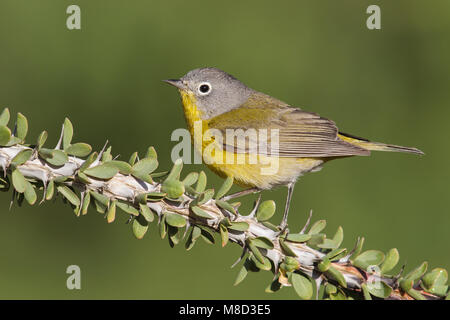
0,0,450,299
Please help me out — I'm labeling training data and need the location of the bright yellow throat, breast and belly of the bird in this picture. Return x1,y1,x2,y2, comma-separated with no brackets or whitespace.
180,91,323,189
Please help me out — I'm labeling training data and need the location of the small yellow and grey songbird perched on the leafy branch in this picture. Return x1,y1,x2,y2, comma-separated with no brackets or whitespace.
164,68,423,231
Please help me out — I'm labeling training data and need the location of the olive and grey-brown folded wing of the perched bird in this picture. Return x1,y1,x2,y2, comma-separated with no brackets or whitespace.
208,94,370,158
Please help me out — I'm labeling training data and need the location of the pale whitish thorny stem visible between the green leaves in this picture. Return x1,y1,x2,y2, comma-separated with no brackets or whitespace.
0,143,441,299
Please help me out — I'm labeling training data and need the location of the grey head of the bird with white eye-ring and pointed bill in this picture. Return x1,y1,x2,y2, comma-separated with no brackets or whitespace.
164,68,255,119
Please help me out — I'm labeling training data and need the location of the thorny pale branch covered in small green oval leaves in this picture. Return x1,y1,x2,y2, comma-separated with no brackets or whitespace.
0,109,448,299
